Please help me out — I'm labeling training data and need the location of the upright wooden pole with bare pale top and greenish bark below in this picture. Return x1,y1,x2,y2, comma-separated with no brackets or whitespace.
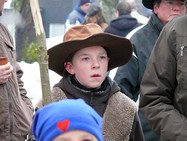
30,0,52,105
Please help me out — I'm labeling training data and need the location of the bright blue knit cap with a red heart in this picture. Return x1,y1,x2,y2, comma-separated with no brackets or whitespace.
32,99,103,141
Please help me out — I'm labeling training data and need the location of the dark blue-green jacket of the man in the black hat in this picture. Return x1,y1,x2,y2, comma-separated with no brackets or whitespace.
114,14,163,141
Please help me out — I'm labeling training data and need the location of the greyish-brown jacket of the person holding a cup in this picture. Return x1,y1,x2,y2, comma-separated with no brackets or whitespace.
0,24,33,141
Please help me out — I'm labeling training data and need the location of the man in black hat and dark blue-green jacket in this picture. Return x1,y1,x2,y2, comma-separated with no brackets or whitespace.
114,0,186,141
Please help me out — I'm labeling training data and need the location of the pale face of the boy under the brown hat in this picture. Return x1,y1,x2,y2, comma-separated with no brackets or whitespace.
66,46,109,89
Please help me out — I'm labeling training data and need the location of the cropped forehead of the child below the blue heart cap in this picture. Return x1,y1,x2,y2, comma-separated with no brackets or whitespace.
53,130,98,141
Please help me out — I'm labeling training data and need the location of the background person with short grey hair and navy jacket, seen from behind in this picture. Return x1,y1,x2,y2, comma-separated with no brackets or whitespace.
105,2,141,37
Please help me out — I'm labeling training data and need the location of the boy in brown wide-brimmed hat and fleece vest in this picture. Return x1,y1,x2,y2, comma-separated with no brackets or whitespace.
48,23,144,141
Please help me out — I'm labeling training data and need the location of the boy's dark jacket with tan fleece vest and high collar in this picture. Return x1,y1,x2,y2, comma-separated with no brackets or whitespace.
52,76,144,141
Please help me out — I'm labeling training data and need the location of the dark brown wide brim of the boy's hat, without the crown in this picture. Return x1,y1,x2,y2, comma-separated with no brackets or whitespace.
47,33,132,76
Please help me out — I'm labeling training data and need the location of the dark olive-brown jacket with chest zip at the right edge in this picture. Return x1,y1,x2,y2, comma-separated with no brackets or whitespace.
140,15,187,141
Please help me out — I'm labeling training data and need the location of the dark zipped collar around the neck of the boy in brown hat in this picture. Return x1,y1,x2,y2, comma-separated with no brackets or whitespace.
54,76,120,116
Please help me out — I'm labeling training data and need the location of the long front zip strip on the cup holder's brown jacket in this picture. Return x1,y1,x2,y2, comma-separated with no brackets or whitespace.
6,83,13,141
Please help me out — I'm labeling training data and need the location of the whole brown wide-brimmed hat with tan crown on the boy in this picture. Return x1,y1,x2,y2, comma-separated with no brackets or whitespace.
47,23,132,76
